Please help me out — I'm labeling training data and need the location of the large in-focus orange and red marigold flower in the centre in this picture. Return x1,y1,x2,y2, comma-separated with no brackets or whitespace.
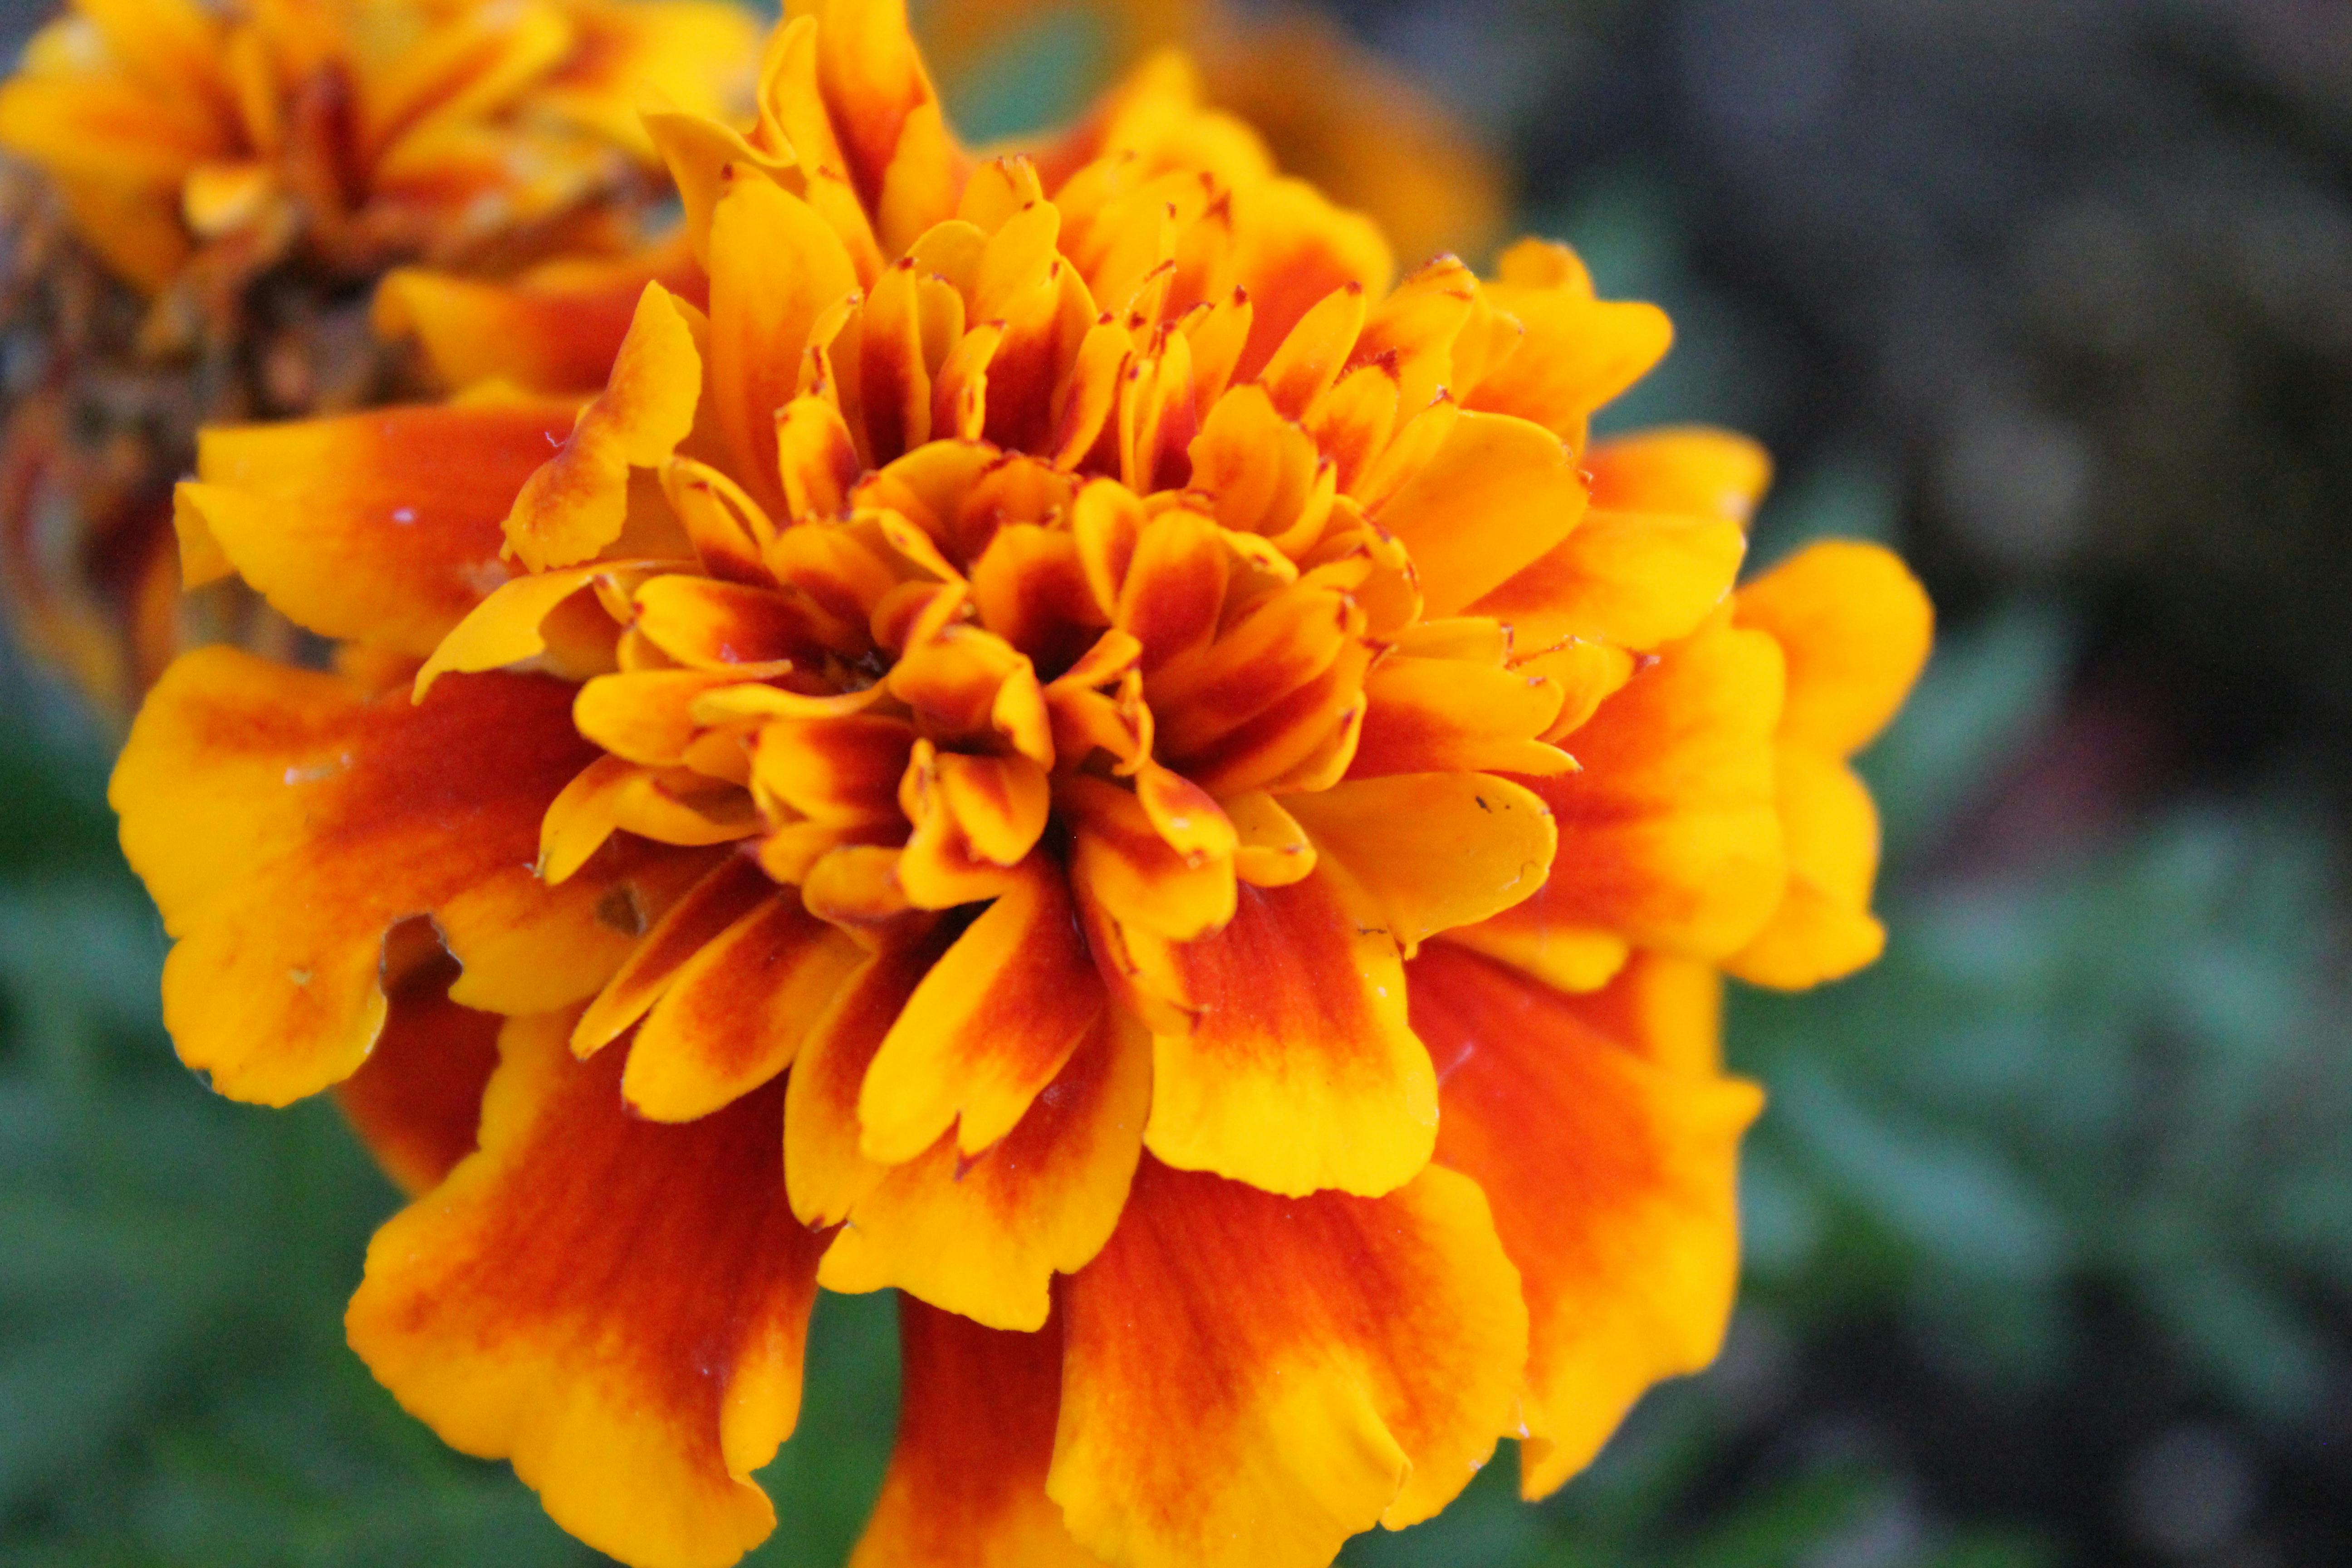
113,0,1929,1568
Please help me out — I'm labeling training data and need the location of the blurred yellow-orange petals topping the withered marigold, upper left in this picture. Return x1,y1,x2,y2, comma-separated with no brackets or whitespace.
0,0,748,291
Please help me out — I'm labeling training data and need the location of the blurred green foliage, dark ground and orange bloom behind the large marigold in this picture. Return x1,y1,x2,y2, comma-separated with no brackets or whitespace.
0,0,2352,1568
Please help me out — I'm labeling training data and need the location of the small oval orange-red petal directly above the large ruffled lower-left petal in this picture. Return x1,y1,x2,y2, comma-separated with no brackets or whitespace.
621,889,863,1122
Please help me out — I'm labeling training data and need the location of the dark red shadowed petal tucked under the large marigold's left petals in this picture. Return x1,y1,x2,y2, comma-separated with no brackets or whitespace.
334,959,503,1196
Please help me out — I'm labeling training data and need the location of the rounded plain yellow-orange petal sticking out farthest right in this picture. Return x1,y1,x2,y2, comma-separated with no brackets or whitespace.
1736,539,1936,757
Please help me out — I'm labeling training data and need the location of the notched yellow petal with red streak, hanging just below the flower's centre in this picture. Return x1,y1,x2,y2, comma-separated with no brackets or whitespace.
858,856,1103,1166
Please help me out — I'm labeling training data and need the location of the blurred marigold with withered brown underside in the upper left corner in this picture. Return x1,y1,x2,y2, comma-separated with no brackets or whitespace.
0,0,753,703
